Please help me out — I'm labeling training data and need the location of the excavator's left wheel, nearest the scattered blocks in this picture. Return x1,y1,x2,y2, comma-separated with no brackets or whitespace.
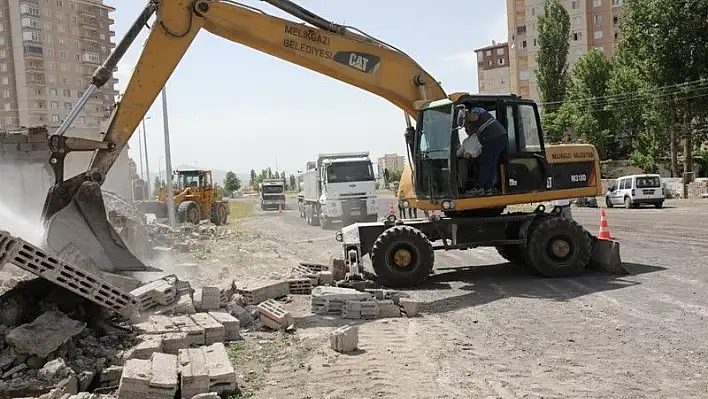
371,226,435,288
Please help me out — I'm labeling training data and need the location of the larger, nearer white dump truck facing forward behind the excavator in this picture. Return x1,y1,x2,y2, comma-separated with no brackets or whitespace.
298,152,378,228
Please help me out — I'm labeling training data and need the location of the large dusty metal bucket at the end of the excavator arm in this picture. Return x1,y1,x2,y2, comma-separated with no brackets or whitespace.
44,182,161,273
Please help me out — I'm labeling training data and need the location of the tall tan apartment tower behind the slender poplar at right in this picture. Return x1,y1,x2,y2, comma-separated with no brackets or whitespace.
506,0,622,101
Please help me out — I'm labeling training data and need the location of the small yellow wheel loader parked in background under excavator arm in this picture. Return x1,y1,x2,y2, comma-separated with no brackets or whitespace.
138,169,229,226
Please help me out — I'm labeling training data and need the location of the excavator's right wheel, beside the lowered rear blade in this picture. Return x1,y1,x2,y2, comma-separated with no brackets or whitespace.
525,217,592,277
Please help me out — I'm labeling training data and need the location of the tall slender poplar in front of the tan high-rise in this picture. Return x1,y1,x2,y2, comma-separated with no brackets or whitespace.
534,0,570,112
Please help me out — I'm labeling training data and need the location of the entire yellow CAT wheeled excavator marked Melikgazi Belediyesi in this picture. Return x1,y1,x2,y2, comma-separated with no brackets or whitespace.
42,0,618,287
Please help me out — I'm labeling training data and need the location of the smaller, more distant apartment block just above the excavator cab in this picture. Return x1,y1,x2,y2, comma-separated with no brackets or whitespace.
474,40,511,94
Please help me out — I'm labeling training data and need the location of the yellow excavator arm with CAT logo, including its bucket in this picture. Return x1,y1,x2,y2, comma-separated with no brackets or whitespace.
42,0,446,271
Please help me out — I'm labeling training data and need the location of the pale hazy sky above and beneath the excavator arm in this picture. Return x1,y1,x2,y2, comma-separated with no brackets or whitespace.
113,0,507,178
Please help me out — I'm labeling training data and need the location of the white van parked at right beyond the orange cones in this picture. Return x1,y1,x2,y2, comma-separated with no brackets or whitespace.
605,175,664,209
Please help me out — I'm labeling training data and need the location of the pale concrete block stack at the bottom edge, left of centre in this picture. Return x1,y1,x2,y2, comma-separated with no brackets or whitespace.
117,342,236,399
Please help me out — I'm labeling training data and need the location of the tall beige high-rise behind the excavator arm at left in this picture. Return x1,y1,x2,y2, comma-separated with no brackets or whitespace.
0,0,130,200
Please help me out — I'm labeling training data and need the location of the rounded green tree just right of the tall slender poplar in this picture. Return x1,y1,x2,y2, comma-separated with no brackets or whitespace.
556,49,612,159
